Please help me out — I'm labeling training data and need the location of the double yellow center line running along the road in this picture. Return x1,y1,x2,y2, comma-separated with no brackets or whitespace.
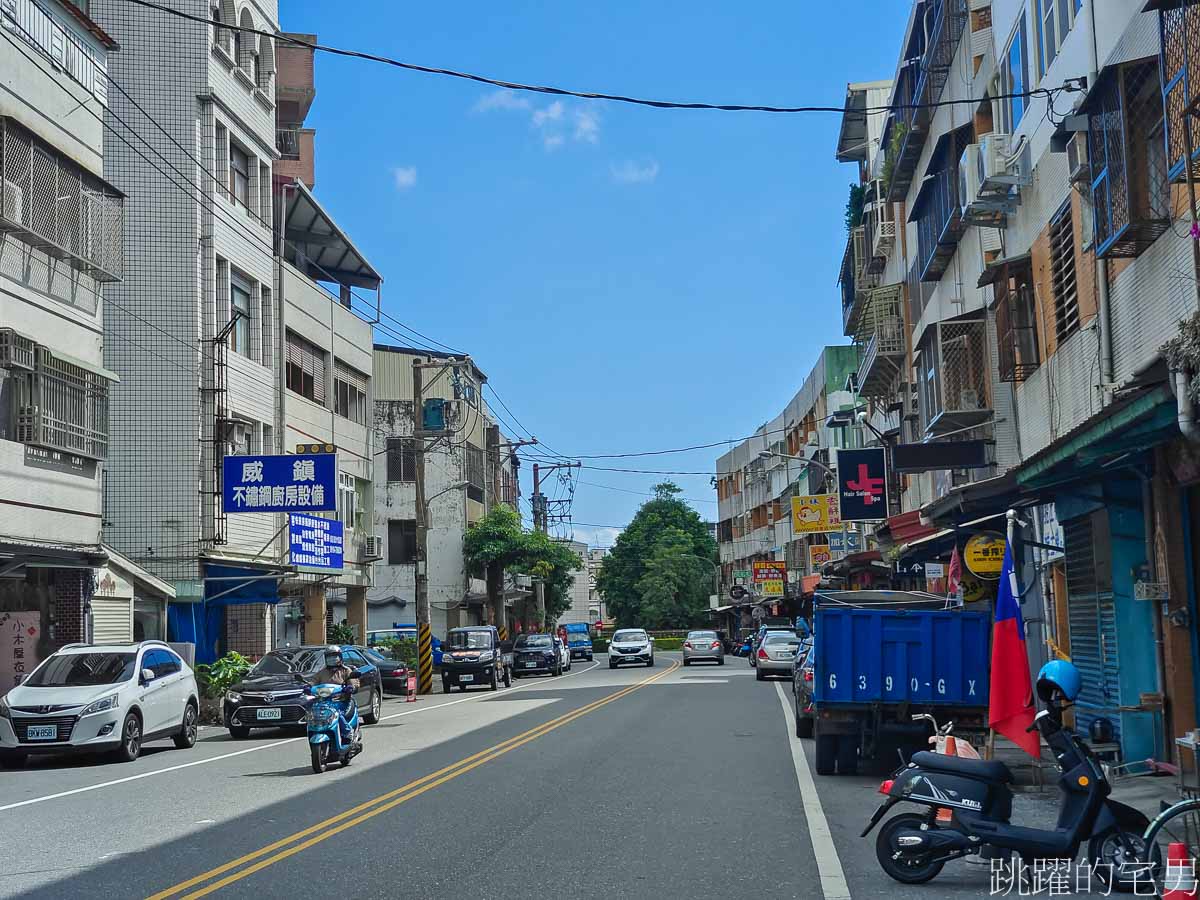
149,662,679,900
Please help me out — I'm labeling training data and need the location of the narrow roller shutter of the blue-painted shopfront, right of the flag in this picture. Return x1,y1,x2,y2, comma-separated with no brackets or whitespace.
1062,510,1121,739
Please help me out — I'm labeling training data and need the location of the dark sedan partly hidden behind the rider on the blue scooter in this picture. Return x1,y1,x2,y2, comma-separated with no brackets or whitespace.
223,644,383,738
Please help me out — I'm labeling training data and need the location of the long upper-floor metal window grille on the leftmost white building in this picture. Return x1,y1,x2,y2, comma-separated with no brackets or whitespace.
0,116,125,282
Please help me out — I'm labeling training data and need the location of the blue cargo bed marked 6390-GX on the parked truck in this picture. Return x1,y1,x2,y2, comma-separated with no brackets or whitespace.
812,606,991,706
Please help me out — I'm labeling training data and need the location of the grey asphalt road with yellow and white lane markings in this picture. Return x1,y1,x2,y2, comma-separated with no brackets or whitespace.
0,653,1060,900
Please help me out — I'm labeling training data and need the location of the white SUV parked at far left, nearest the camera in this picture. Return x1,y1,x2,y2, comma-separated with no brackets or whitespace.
0,641,200,768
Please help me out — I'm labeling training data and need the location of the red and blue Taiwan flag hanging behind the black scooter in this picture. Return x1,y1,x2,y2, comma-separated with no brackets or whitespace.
988,545,1040,757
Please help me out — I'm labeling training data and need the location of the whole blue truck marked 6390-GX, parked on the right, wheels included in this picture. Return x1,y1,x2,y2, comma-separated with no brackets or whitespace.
793,590,991,775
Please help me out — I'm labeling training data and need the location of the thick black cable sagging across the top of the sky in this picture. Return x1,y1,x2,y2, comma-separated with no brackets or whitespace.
119,0,1064,114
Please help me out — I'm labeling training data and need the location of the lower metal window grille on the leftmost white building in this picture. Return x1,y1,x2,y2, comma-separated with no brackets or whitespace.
16,347,108,460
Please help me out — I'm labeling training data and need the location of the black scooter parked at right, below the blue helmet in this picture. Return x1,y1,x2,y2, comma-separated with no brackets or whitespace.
862,700,1150,890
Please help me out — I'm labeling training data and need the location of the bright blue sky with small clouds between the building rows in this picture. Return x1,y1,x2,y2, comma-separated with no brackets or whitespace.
281,0,908,546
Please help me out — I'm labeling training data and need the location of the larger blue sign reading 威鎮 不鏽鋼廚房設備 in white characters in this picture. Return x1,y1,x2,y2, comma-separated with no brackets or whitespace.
221,454,337,512
